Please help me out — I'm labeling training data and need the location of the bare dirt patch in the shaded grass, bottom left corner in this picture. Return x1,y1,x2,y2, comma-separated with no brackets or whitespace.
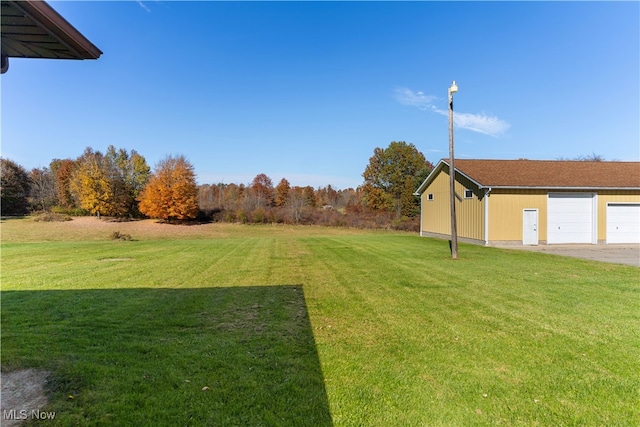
1,369,49,426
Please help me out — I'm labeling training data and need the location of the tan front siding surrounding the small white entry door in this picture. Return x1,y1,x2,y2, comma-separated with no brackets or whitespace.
489,190,547,241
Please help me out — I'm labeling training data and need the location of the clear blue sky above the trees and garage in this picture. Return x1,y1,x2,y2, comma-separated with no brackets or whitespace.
0,1,640,188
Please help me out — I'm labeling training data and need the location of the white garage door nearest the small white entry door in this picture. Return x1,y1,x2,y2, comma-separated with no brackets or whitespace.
547,193,596,244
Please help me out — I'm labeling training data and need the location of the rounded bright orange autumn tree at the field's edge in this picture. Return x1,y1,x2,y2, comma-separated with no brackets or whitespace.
138,156,198,221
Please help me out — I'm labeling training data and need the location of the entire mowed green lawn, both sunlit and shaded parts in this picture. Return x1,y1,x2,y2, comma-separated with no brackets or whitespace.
1,219,640,426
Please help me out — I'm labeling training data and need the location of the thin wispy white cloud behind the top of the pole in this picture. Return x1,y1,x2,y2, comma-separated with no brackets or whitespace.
395,88,511,137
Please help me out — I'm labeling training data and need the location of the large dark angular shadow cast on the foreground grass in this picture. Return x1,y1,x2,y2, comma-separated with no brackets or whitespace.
2,286,332,426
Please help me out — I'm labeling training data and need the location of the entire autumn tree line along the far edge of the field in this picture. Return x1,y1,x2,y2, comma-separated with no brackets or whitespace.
0,141,433,230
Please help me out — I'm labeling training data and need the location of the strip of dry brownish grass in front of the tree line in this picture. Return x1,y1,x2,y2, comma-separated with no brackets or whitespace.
0,217,370,243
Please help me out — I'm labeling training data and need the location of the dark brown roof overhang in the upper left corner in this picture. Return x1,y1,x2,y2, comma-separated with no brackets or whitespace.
0,0,102,73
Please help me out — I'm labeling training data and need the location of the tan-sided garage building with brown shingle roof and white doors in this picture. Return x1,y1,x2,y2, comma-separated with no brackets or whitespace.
415,159,640,246
